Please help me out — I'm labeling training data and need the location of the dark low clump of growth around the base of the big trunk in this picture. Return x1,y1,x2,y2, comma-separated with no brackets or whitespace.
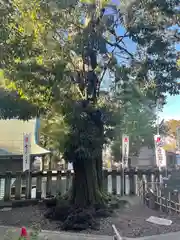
45,192,128,231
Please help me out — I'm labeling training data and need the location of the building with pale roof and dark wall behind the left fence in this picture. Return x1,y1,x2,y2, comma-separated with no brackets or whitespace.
0,119,50,173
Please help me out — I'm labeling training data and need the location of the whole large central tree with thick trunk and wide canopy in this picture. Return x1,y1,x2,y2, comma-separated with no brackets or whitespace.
0,0,179,231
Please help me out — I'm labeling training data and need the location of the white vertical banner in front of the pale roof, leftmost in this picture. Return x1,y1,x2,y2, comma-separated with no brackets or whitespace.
23,134,31,172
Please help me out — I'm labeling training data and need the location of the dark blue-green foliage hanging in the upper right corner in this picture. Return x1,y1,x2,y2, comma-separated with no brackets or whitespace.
118,0,180,97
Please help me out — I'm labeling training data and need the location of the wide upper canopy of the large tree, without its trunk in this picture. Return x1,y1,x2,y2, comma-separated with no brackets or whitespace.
0,0,179,117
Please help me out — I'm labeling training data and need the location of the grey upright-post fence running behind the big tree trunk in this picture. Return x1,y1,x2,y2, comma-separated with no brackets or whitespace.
0,169,169,201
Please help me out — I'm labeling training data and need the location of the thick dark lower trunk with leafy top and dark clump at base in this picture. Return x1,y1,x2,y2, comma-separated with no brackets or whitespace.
43,104,114,230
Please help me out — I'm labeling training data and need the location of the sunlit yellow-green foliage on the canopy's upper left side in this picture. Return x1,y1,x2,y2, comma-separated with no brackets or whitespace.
1,1,80,110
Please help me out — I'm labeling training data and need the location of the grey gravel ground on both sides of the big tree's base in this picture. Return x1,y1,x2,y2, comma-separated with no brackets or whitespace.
0,202,180,237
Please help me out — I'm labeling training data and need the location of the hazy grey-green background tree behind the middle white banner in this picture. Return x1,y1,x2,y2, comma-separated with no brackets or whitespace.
112,101,156,162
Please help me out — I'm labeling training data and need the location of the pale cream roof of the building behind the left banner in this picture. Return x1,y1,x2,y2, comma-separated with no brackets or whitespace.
0,119,50,156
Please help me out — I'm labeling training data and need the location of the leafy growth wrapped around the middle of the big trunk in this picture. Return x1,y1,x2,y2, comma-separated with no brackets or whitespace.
40,95,117,160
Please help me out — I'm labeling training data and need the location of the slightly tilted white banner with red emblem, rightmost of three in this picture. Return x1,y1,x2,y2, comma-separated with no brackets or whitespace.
154,135,167,168
